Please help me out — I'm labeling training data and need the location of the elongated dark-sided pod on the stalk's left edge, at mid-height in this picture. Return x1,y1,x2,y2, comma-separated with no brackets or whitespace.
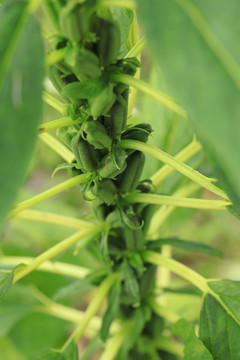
71,131,99,171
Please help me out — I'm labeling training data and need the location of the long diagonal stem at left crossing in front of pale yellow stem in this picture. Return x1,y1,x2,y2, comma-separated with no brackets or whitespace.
13,225,104,283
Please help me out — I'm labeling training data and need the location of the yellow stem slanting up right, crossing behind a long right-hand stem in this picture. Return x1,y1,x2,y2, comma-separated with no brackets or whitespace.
150,139,201,187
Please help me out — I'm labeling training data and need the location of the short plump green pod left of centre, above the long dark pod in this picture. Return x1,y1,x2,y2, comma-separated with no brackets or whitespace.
84,121,112,149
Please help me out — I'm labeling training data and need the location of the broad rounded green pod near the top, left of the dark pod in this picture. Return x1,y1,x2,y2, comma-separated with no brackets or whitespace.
73,49,102,81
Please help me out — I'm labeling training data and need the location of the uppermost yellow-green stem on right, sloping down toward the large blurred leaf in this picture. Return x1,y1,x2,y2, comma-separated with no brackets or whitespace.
112,74,187,118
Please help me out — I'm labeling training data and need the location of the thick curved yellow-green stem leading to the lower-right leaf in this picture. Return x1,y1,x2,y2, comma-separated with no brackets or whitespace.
142,251,209,293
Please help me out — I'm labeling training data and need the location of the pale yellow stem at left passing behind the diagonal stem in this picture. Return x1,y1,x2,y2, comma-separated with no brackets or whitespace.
1,256,90,279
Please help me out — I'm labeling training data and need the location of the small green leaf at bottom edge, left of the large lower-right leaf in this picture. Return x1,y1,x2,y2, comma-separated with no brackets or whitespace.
172,319,213,360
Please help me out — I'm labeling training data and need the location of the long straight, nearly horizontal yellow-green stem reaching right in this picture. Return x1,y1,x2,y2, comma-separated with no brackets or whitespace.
125,193,231,210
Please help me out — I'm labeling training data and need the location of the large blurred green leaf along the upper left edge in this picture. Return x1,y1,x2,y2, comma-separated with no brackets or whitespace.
0,1,44,229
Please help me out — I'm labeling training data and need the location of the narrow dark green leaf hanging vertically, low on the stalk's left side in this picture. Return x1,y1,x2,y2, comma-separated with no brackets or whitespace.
100,282,121,341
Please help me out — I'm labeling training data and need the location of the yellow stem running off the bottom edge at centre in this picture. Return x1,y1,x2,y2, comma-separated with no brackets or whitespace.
99,321,133,360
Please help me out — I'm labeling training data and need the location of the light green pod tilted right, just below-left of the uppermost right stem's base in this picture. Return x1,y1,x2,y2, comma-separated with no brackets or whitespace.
89,84,116,119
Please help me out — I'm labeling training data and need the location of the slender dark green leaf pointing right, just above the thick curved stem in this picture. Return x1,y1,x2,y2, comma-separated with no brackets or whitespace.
148,238,223,258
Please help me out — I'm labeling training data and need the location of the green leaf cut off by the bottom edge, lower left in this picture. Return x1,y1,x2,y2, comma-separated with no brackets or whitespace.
31,342,78,360
